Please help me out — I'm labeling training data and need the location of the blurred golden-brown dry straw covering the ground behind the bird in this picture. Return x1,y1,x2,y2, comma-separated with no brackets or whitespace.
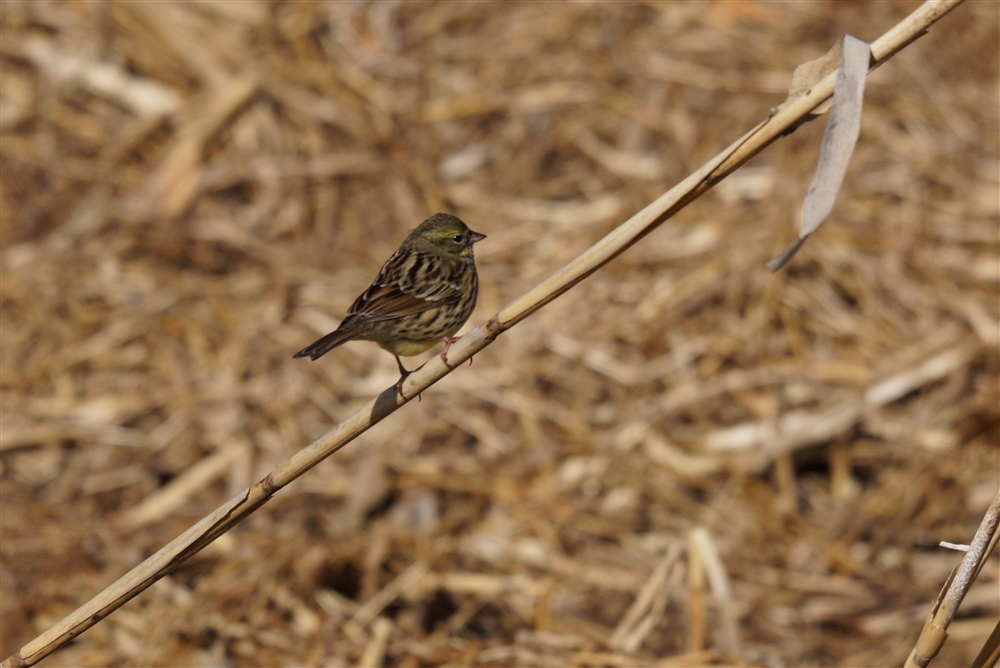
0,2,1000,666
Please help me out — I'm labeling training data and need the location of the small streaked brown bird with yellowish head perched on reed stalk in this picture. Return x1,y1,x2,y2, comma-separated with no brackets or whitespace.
295,213,486,393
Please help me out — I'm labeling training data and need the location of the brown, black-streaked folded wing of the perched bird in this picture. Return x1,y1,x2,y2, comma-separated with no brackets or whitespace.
345,250,464,325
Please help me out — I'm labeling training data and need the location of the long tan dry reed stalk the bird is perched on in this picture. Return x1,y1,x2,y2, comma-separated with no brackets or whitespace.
0,0,962,668
